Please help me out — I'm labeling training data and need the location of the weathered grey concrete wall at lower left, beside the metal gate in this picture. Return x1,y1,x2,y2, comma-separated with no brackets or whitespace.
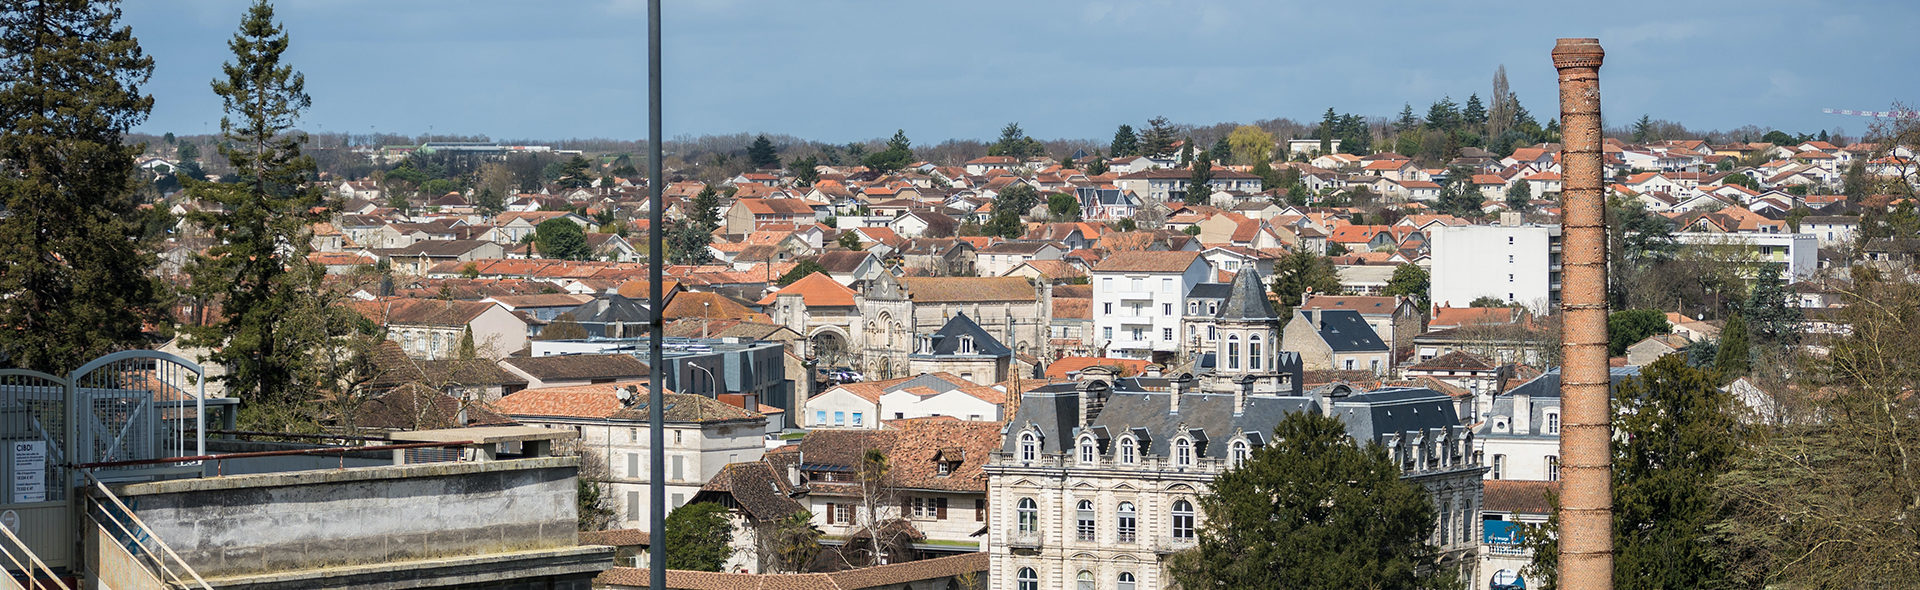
115,457,578,577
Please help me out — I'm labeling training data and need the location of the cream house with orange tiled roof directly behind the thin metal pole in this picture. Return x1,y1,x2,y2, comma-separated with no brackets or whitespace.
493,381,766,529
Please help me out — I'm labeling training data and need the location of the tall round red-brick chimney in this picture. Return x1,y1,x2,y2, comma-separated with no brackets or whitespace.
1553,38,1613,590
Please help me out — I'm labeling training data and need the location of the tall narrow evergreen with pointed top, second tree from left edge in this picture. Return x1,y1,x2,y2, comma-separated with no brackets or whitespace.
188,0,330,430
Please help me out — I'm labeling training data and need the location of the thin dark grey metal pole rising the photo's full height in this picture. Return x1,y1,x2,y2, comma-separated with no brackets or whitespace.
645,0,666,588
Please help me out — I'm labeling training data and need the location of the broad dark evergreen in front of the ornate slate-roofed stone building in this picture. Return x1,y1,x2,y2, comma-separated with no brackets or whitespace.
1167,411,1459,588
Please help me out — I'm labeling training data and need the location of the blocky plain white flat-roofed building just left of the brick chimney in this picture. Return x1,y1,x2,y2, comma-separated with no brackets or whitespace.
1427,223,1561,313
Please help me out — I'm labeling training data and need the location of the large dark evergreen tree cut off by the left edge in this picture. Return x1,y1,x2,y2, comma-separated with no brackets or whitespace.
0,0,163,373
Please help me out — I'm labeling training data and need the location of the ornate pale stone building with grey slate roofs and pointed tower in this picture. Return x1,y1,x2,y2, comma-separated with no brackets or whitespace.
987,273,1484,590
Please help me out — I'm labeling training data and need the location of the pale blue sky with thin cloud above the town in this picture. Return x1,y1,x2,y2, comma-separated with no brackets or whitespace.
123,0,1920,144
